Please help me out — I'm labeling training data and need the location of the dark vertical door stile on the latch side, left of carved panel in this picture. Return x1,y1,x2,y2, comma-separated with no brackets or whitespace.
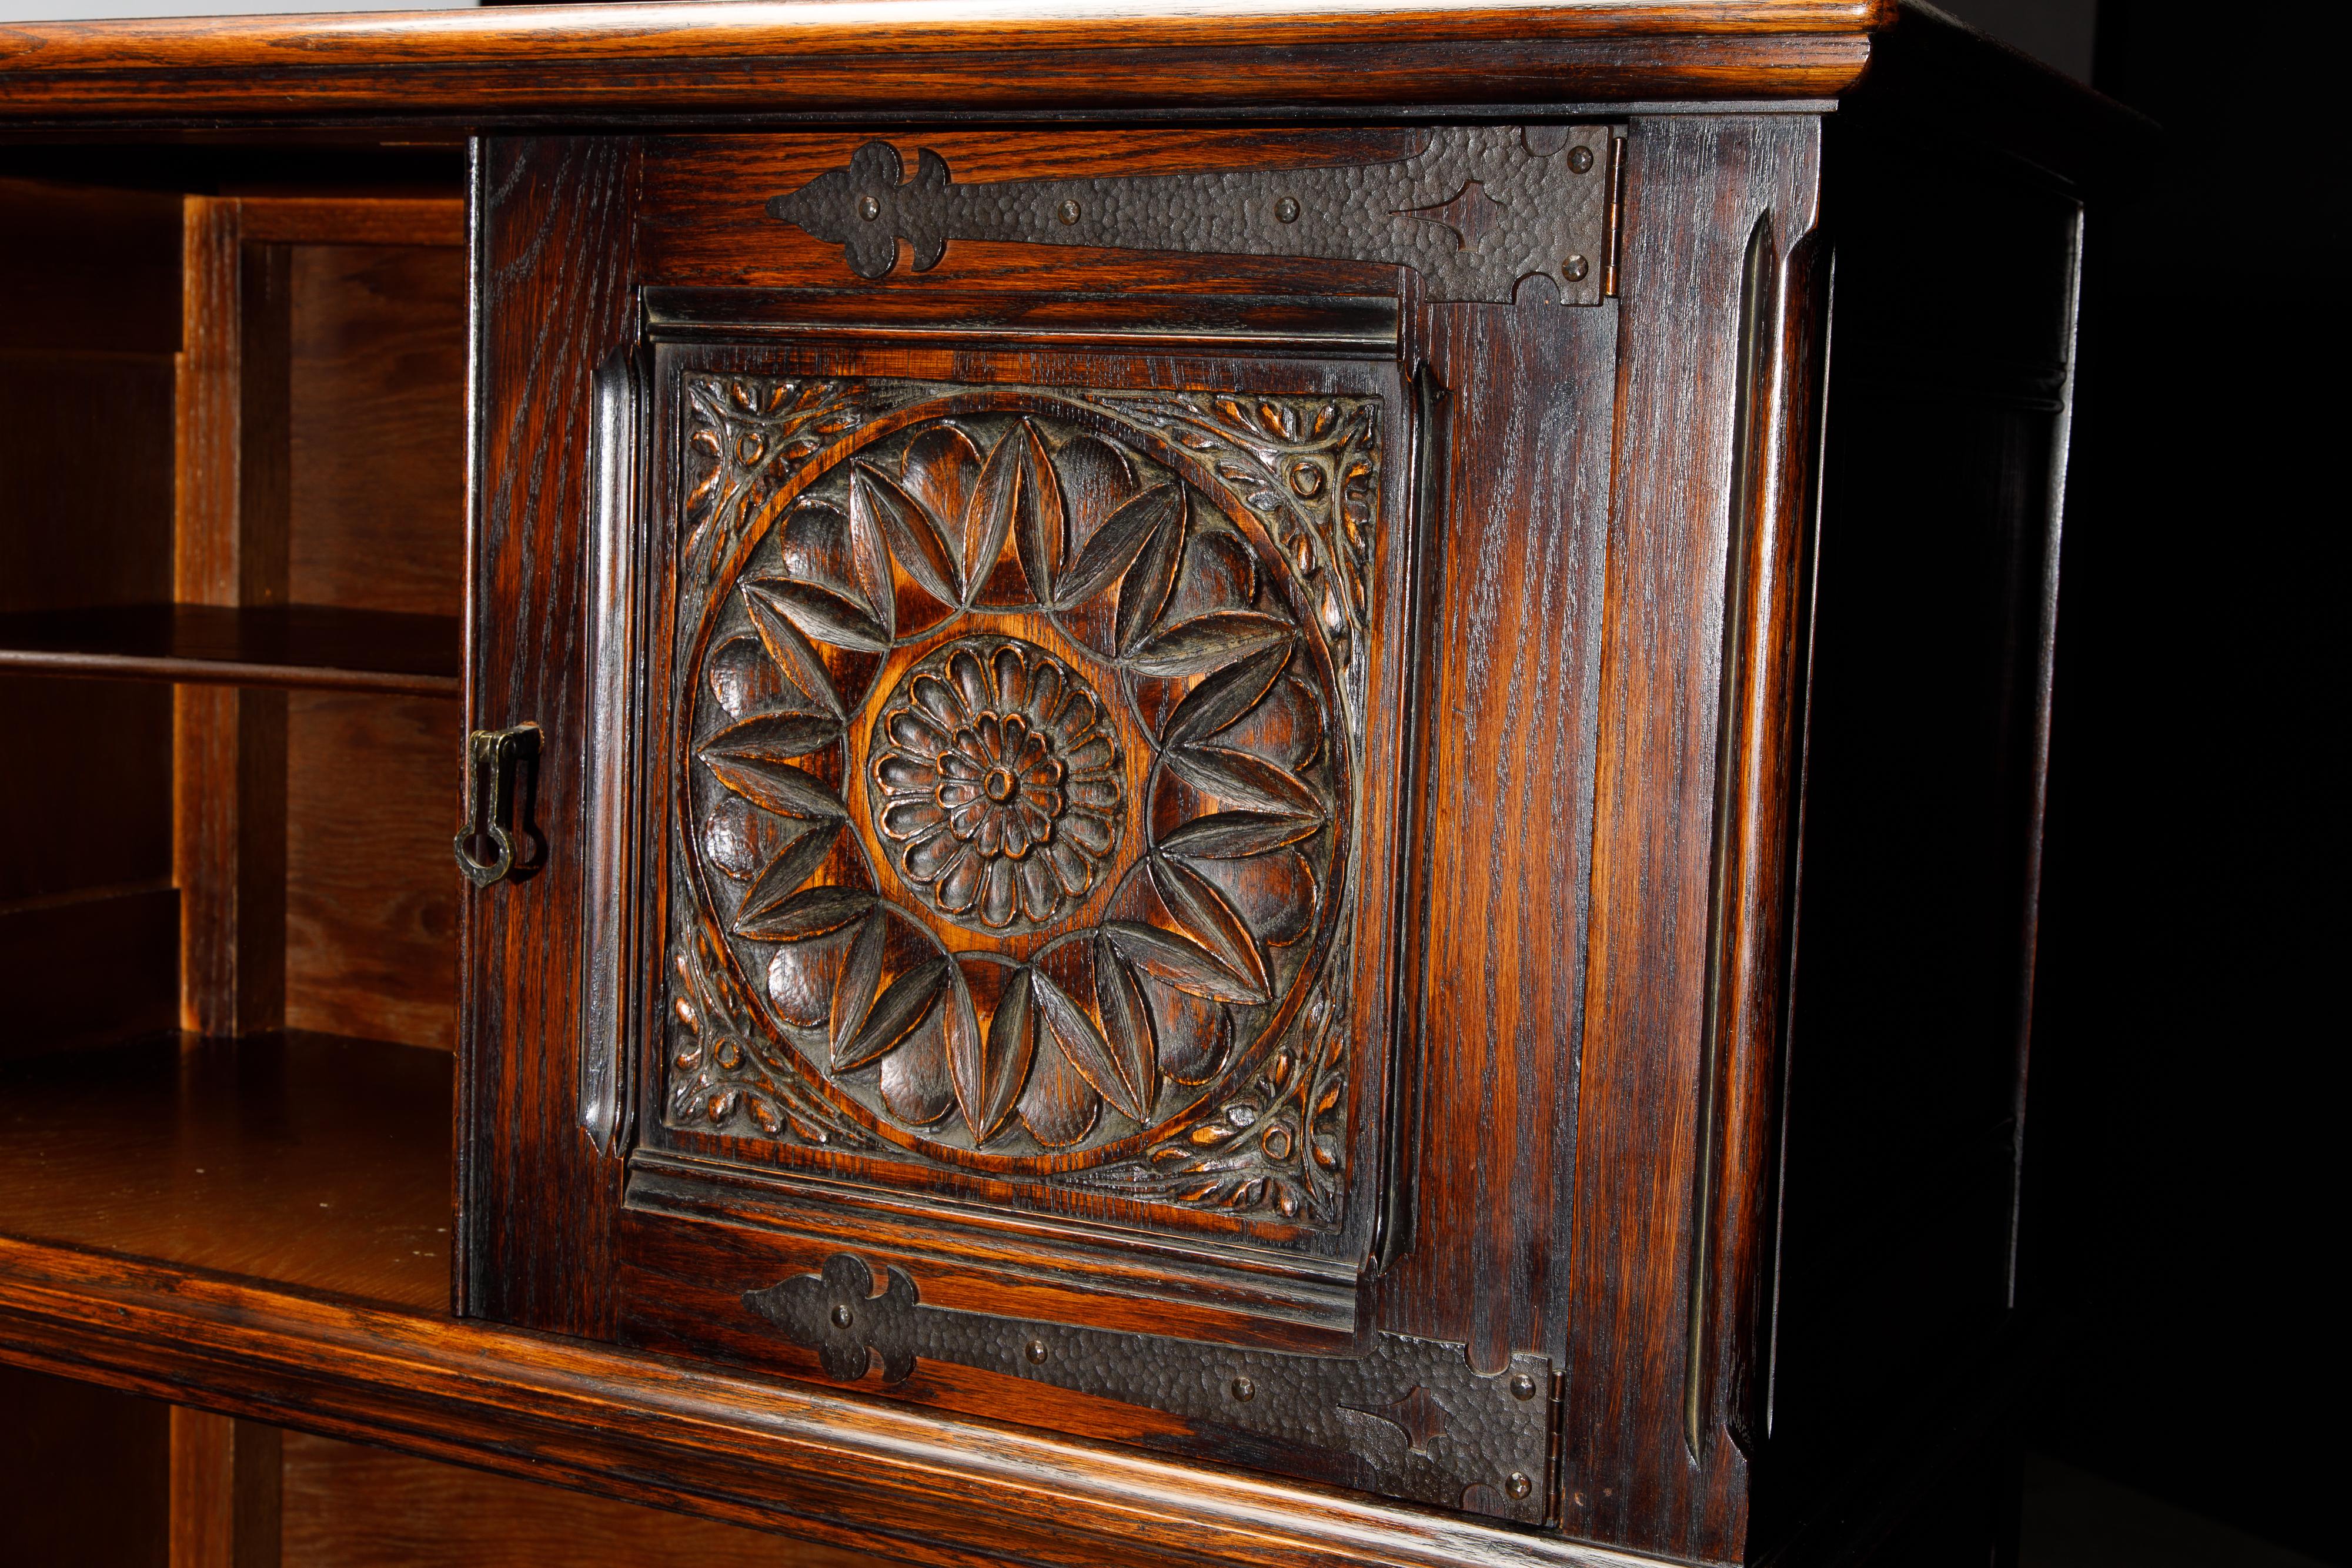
452,136,637,1335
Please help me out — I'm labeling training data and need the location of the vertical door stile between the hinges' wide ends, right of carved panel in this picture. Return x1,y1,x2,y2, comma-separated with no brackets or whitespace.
1378,289,1618,1368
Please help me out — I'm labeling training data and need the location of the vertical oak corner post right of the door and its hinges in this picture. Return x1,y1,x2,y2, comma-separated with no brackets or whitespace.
1562,118,1820,1561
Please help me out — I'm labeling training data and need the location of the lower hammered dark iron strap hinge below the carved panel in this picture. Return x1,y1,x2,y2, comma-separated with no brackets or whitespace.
743,1253,1555,1523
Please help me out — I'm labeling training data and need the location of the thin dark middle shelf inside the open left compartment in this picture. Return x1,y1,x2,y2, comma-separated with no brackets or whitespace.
0,604,463,696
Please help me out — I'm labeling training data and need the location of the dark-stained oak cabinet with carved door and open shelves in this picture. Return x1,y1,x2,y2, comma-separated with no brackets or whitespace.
0,2,2138,1566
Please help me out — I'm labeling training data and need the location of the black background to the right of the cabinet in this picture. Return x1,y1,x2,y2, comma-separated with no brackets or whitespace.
1947,0,2352,1561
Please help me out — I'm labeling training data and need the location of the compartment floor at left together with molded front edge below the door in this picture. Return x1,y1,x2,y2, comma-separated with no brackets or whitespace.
0,1034,1653,1568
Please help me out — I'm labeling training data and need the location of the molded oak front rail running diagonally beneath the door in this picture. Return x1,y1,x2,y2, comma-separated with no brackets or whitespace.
0,1239,1693,1568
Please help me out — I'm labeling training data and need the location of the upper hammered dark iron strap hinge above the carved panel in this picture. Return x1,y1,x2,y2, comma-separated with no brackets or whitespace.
767,125,1623,306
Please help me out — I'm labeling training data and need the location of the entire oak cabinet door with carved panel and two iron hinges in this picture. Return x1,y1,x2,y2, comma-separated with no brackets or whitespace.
459,125,1621,1526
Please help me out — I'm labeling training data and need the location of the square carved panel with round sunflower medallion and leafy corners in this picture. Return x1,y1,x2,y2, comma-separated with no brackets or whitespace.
663,372,1381,1227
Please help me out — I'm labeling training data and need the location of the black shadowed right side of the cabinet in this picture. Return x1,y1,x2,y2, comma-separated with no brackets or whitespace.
1771,120,2079,1542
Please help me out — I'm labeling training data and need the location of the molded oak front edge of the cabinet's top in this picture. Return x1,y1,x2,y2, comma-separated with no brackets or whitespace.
0,0,1896,125
